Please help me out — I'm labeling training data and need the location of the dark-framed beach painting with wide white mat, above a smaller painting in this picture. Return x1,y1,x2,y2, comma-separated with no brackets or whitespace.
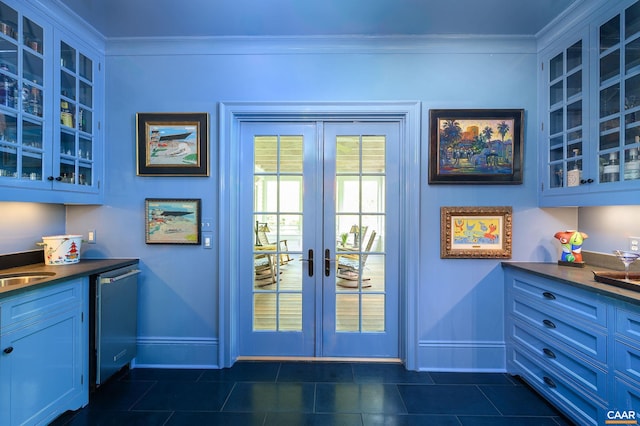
136,112,209,176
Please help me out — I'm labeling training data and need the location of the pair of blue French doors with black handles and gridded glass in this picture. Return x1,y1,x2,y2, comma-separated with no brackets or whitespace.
238,121,400,358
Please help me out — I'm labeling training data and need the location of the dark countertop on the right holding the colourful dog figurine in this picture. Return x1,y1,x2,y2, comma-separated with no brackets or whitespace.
502,262,640,304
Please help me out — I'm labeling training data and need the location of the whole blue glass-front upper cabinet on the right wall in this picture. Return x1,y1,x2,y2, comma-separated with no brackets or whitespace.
539,0,640,206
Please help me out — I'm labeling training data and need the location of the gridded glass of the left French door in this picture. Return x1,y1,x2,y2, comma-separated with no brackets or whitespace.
252,135,306,332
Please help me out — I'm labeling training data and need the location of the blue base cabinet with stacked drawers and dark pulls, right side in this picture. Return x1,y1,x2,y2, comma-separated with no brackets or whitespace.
505,266,640,425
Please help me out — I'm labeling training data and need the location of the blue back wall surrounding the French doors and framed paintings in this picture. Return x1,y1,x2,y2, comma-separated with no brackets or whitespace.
67,38,576,370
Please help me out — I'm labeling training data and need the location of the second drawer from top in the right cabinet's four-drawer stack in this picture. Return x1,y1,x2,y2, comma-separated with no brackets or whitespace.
512,299,607,364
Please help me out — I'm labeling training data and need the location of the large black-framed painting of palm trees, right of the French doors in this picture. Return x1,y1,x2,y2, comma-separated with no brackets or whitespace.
429,109,524,184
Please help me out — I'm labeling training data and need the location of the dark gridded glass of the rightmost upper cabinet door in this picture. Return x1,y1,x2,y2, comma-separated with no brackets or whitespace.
597,2,640,183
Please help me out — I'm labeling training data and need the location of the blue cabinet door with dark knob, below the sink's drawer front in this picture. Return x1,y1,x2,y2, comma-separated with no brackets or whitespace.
0,309,83,425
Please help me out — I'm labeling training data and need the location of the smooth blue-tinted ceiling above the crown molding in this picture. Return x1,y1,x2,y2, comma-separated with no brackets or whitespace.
55,0,583,38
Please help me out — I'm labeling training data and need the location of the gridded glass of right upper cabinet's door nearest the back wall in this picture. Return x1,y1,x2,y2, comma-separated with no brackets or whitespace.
543,39,587,188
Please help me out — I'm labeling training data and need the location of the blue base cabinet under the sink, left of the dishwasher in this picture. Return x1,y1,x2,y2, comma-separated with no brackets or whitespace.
0,278,89,426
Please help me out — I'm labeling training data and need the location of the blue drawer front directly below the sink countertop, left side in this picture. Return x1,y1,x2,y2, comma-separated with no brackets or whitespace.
0,278,84,332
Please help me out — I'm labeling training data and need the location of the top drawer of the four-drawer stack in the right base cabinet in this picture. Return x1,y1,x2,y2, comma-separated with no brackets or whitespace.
513,277,607,327
